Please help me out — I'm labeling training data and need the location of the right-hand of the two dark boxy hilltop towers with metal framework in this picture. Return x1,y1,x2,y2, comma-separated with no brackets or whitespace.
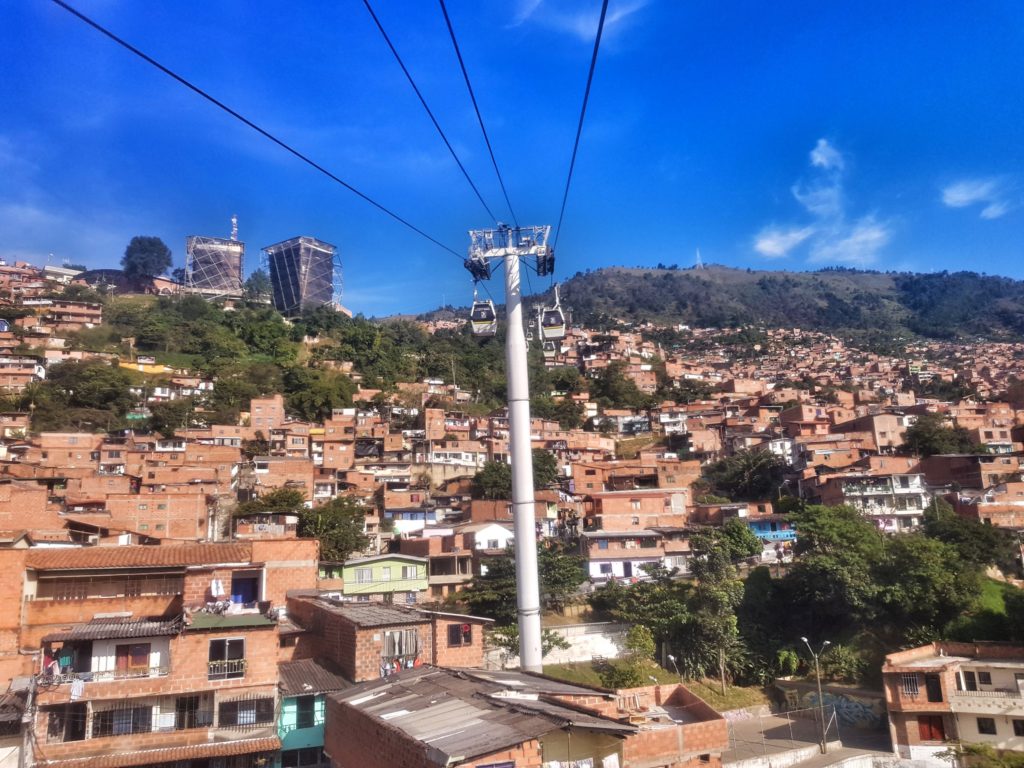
263,237,342,316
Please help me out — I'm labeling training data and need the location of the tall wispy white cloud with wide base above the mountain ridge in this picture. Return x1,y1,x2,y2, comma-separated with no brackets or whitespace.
754,138,892,266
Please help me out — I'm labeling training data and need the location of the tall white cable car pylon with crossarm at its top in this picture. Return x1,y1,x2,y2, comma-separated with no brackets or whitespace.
466,224,554,672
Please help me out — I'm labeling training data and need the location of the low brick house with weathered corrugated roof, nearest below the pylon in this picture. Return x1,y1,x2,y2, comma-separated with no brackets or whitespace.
325,667,728,768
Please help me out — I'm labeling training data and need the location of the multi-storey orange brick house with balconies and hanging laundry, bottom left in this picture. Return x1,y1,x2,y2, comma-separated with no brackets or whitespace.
0,540,318,768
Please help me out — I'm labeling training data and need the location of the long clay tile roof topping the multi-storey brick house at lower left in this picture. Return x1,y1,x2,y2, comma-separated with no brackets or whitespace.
26,542,252,570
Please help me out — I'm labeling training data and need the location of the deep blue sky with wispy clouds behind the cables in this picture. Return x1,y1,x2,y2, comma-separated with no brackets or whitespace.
0,0,1024,314
